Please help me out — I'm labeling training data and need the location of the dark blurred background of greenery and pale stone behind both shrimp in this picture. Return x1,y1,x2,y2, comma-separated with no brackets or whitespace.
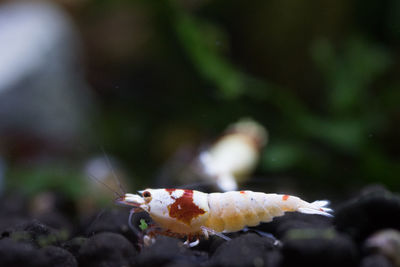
0,0,400,208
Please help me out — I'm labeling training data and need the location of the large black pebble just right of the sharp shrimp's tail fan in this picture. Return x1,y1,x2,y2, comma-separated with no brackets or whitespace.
334,186,400,243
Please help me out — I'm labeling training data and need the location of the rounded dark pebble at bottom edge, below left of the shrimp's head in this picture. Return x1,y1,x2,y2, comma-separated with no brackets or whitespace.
78,233,137,266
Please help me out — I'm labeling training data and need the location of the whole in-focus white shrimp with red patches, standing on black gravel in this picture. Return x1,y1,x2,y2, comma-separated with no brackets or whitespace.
117,189,332,248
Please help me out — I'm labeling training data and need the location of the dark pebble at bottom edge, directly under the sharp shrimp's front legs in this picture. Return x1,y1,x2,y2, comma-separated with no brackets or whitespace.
137,236,208,266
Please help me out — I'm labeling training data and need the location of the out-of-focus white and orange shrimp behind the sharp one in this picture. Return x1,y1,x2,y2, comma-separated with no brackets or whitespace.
158,118,268,192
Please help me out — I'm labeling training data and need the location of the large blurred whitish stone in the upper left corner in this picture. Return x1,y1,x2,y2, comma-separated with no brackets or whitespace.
0,1,91,146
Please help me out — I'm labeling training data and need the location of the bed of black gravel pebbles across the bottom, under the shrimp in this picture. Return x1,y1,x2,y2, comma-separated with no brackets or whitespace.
0,186,400,267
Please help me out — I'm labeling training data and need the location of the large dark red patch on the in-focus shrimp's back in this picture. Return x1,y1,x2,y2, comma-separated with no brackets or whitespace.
168,190,205,225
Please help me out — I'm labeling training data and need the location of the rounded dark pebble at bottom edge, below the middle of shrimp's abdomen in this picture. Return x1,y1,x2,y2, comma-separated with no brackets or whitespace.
210,233,280,267
